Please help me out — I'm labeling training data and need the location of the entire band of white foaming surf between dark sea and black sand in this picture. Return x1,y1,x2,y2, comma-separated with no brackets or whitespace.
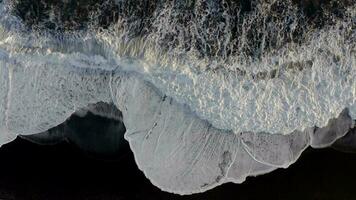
0,0,356,194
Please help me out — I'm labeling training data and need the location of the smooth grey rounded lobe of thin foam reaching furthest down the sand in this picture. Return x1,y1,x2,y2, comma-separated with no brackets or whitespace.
112,74,309,194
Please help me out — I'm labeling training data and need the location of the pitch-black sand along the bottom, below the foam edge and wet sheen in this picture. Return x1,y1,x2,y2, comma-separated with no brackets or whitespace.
0,139,356,200
